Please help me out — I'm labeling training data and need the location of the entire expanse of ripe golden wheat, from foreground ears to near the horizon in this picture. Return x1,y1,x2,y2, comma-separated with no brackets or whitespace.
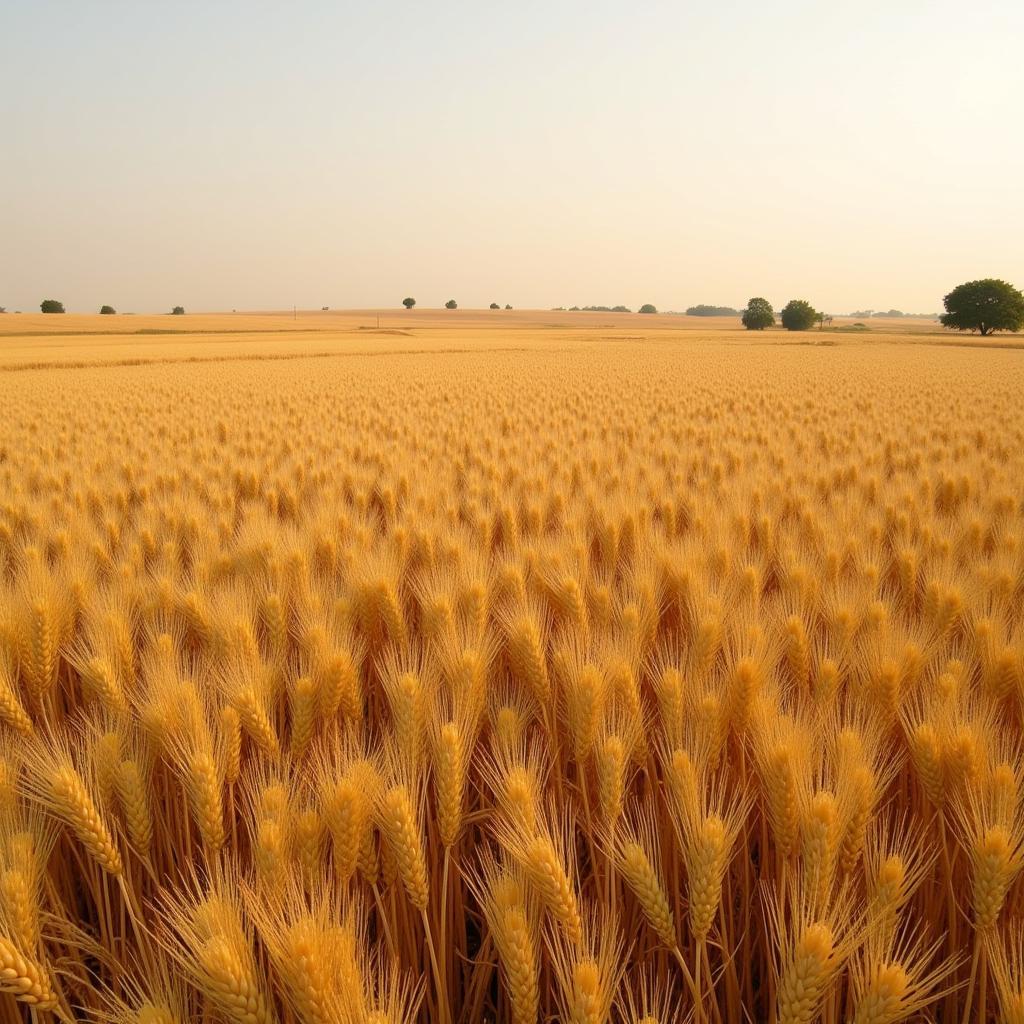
0,314,1024,1024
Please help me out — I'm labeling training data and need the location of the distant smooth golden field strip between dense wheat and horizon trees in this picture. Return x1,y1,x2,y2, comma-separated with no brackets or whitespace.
0,309,991,370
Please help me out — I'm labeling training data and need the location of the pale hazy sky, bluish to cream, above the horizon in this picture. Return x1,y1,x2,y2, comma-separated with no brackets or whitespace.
0,0,1024,312
